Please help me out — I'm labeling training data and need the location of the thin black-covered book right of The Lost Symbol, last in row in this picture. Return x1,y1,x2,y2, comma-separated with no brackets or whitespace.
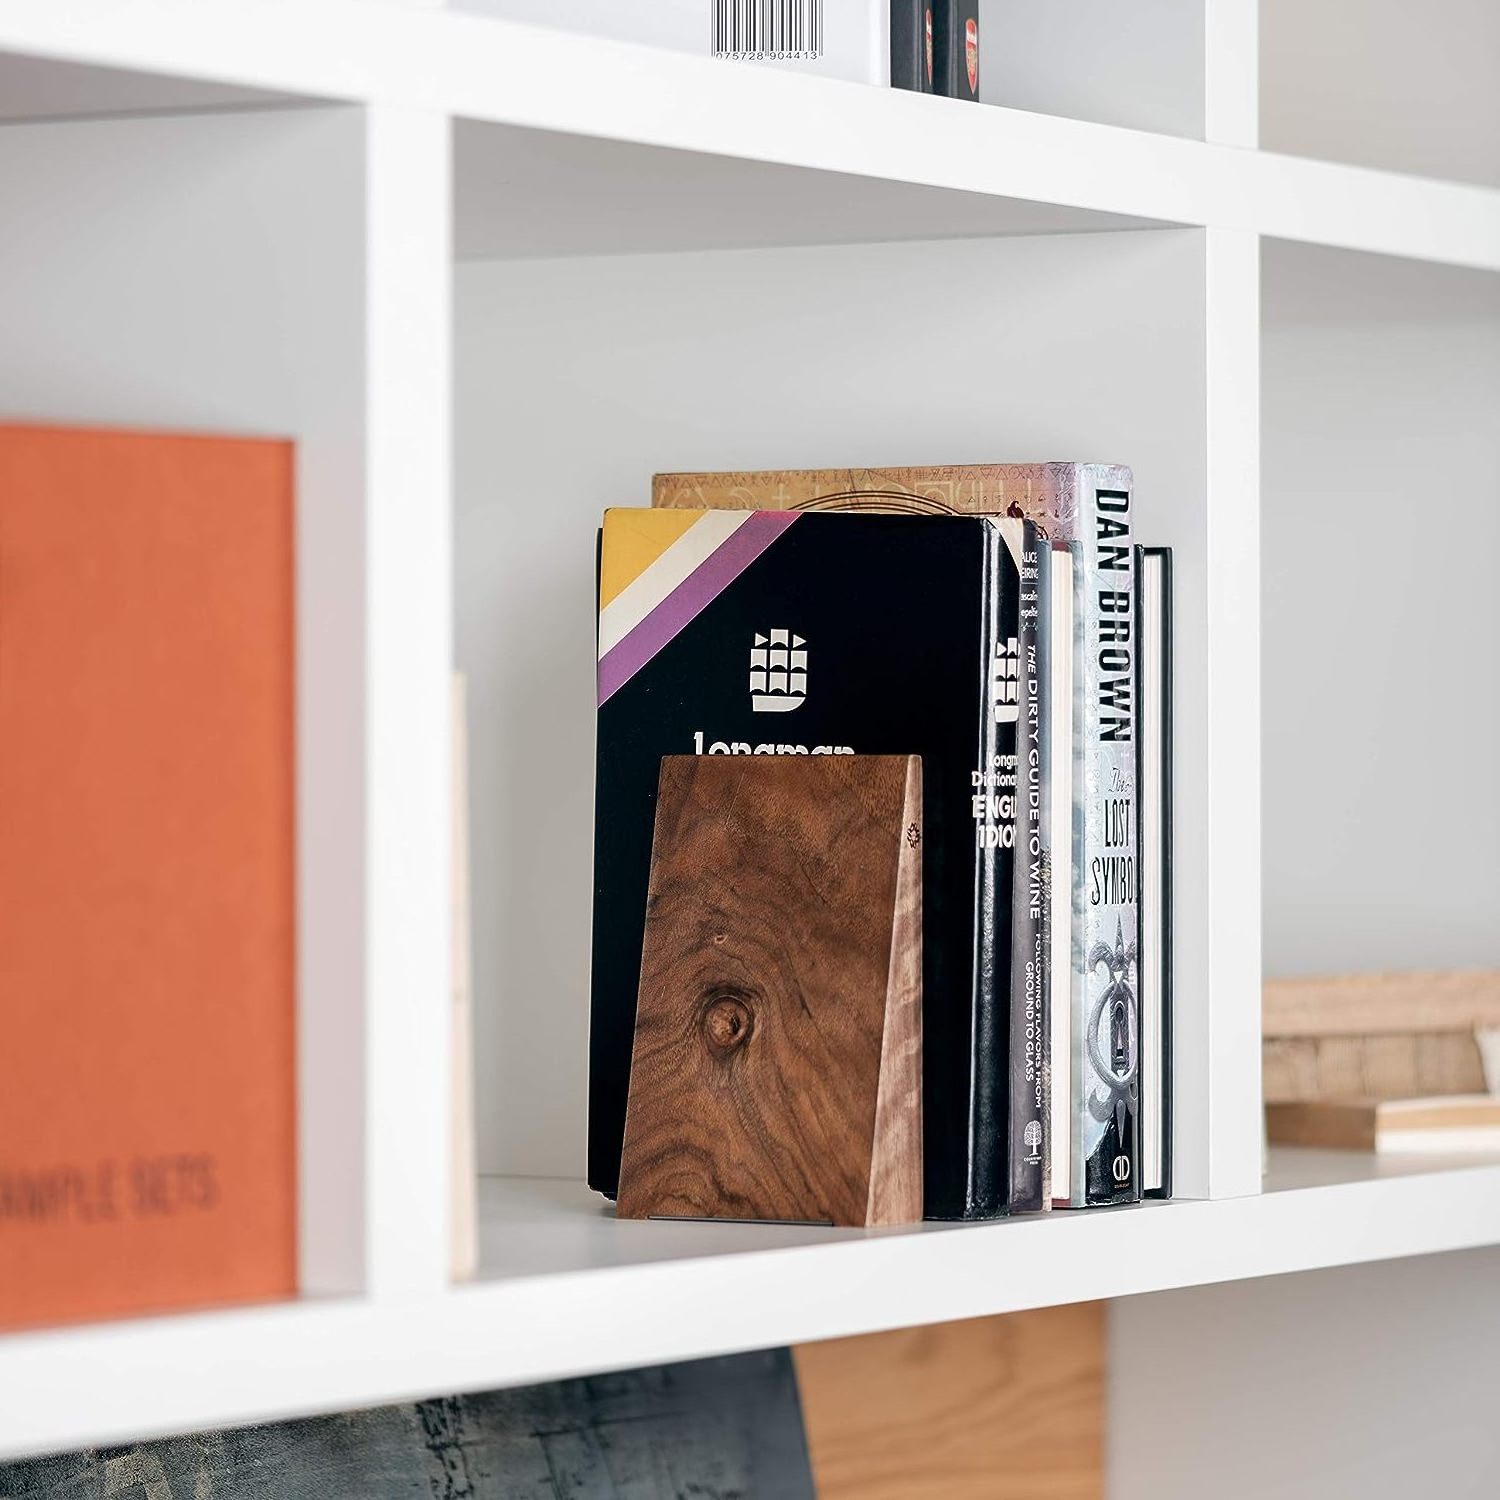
1136,548,1172,1199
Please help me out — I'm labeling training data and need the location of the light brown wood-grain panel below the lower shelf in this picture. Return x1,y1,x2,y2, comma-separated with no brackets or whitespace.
794,1302,1106,1500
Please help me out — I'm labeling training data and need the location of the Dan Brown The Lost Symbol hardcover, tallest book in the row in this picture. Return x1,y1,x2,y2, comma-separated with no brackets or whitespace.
651,462,1146,1208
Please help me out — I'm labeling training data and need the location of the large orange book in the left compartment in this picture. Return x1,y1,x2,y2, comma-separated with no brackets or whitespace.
0,426,297,1328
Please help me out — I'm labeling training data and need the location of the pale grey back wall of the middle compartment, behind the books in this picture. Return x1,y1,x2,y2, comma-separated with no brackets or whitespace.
456,231,1206,1176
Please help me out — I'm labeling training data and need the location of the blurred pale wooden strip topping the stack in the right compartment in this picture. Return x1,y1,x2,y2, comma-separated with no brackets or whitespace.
1262,969,1500,1037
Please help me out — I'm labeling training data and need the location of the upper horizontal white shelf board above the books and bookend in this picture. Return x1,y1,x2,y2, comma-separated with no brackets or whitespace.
0,0,1500,269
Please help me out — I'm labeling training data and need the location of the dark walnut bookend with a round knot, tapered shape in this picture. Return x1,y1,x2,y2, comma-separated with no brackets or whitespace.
618,755,923,1226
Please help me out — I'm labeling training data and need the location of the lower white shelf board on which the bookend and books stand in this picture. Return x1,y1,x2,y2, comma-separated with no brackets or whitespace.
0,1151,1500,1457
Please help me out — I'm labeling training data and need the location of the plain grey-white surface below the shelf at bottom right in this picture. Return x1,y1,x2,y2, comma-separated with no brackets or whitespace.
1107,1250,1500,1500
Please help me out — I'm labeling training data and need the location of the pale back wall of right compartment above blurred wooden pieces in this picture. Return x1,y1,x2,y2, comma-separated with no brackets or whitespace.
1262,243,1500,977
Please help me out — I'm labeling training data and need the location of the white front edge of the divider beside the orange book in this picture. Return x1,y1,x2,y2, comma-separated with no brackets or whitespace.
365,104,453,1298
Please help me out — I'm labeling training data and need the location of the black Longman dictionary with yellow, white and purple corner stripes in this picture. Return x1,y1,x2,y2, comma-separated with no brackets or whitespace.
588,510,1038,1218
